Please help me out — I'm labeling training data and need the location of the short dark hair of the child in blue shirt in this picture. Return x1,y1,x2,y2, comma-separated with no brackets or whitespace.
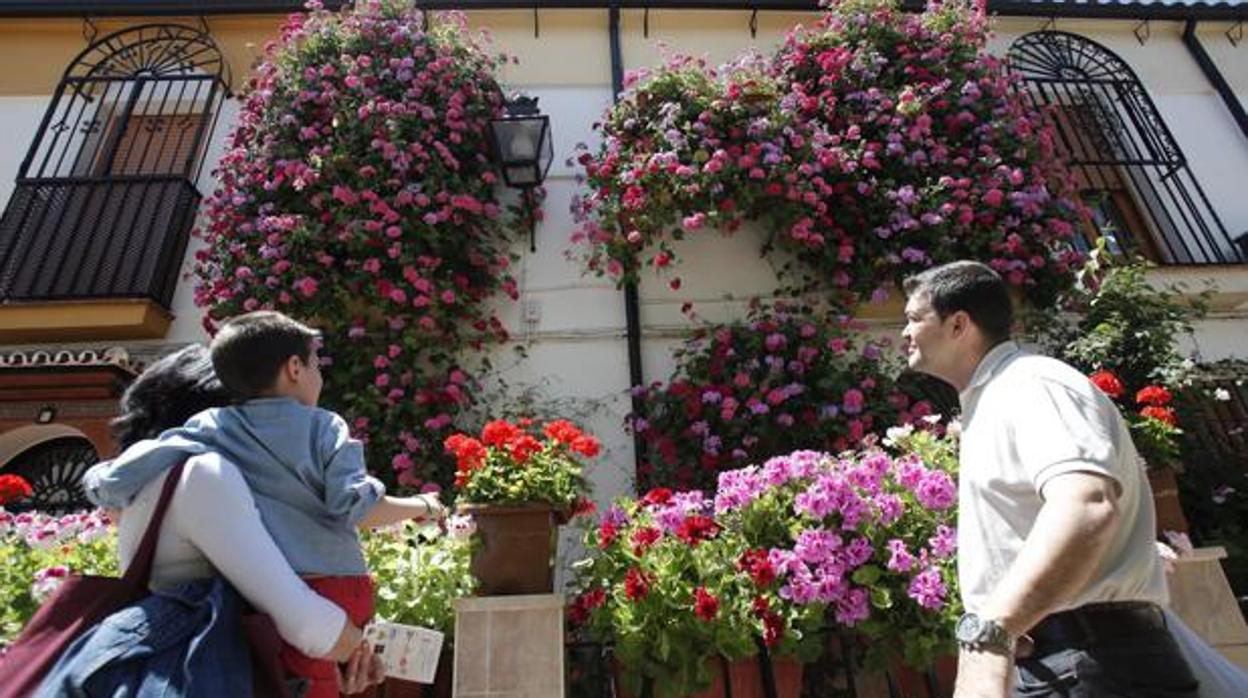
208,310,321,400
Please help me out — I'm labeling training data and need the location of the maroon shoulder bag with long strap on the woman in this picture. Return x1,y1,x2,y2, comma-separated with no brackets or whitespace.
0,462,186,698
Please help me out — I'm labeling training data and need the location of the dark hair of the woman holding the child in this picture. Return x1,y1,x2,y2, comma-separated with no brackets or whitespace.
109,345,231,448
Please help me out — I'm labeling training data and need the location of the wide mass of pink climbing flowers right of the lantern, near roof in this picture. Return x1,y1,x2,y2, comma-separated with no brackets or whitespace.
573,0,1081,305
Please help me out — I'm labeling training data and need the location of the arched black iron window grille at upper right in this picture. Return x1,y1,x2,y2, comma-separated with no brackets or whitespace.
1008,31,1248,265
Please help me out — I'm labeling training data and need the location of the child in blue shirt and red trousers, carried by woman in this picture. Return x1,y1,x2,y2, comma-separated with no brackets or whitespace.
82,311,446,698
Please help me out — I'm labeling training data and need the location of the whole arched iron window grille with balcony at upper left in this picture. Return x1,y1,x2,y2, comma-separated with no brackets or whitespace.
0,24,230,307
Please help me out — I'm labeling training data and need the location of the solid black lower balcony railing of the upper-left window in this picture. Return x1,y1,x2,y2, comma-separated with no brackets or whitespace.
0,175,200,307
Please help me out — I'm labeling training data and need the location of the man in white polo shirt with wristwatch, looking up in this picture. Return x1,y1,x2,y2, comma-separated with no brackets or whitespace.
902,262,1196,698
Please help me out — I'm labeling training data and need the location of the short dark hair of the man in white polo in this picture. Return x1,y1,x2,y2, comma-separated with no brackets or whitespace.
902,260,1013,346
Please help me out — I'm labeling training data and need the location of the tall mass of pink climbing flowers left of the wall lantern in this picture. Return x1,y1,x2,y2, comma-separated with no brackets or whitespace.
195,0,529,487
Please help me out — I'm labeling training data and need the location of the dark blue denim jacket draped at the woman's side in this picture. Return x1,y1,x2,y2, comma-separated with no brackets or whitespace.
34,577,253,698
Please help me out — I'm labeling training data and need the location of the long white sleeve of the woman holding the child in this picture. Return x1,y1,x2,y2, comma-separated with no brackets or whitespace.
165,453,347,657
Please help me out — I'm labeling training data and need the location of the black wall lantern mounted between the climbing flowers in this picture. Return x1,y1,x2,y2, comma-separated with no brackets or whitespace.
489,95,554,251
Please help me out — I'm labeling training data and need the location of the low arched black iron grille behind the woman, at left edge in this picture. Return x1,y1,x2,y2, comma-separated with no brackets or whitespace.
4,436,100,513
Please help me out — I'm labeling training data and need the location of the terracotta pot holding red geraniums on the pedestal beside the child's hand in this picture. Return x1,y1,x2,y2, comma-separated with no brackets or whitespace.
461,504,555,596
